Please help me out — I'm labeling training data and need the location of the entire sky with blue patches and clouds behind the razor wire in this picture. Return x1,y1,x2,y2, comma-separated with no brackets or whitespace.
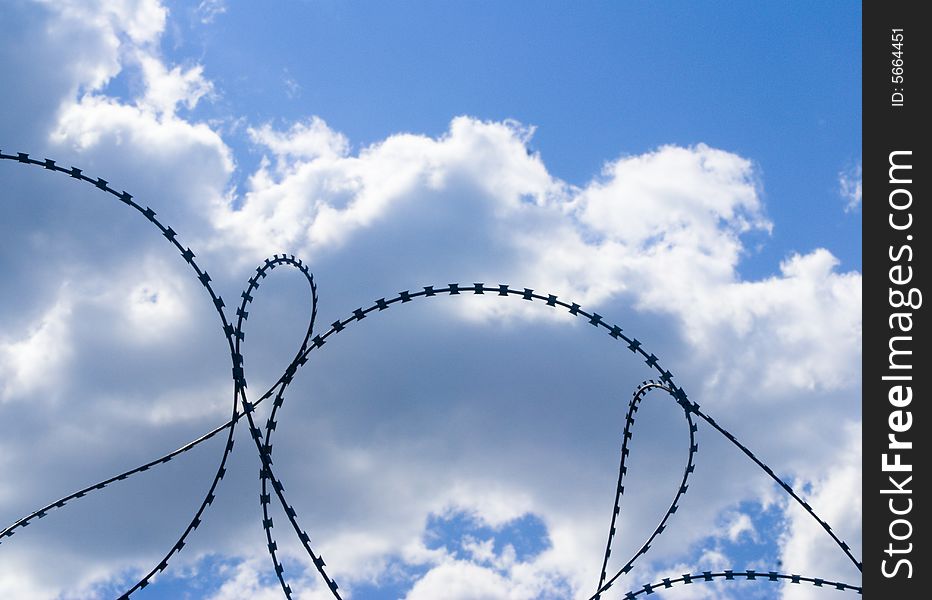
0,0,861,600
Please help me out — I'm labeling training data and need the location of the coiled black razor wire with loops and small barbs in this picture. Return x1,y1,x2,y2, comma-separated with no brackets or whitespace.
0,151,862,600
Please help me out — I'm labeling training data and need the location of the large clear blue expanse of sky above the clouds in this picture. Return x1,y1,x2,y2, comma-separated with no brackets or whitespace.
155,2,861,277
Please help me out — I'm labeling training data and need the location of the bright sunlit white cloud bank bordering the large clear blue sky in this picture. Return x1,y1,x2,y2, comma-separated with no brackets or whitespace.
219,118,860,404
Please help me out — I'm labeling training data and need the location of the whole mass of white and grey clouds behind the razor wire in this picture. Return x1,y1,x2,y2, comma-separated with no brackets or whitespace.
0,1,861,600
